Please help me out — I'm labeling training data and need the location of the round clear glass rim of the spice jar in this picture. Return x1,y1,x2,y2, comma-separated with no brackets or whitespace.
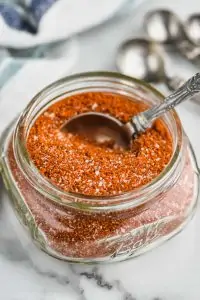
13,71,183,209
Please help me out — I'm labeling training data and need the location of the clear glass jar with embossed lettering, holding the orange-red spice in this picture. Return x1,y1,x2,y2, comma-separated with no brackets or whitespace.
0,72,199,263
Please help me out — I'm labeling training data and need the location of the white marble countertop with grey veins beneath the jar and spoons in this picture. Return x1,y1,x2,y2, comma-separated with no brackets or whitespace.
0,0,200,300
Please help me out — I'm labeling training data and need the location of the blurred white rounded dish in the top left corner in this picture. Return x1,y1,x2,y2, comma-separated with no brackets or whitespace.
0,0,125,48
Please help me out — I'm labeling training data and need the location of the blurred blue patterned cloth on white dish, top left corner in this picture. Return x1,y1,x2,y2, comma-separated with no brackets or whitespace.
0,0,57,34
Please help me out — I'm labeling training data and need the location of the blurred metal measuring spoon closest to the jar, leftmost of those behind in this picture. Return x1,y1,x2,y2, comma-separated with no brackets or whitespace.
116,38,184,91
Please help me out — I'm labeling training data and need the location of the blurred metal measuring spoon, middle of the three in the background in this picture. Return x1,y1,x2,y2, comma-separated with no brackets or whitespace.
144,10,200,65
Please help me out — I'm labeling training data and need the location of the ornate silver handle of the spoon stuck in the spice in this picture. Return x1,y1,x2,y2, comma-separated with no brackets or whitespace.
125,73,200,135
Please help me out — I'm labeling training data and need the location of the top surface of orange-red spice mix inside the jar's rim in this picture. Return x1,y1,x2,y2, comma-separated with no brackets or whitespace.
27,92,172,196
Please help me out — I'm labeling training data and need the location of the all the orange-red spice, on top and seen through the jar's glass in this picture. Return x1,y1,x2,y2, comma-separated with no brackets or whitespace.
7,93,197,261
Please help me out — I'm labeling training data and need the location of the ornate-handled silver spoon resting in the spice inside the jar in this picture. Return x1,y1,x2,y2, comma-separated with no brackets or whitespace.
61,73,200,149
